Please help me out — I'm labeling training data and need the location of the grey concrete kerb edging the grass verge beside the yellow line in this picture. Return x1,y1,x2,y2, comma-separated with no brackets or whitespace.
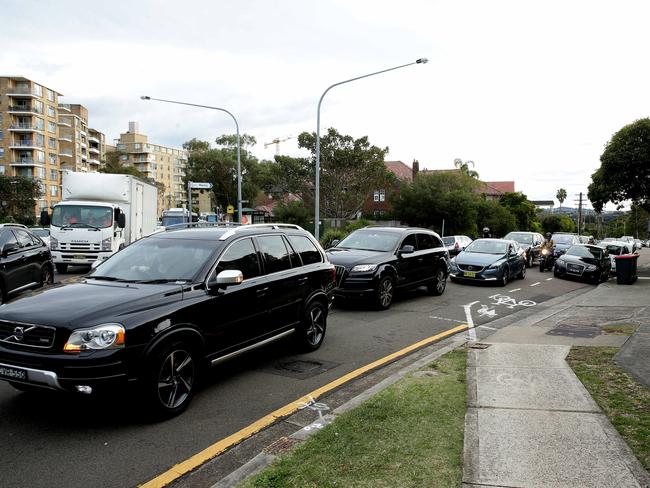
211,335,466,488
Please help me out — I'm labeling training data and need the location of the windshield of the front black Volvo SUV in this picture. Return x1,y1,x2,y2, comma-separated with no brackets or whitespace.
89,237,218,282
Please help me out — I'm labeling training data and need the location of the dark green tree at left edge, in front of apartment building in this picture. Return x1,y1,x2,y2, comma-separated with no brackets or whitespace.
0,175,43,225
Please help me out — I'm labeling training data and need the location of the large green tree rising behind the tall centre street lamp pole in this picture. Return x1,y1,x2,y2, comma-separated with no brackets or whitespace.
298,128,396,218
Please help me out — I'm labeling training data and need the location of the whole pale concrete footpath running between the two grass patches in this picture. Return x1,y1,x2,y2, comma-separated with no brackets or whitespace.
463,273,650,488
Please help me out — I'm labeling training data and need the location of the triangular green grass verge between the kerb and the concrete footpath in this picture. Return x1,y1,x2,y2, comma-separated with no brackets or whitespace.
241,349,467,488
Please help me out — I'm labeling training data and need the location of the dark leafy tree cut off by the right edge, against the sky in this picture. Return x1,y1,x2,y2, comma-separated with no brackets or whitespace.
587,118,650,212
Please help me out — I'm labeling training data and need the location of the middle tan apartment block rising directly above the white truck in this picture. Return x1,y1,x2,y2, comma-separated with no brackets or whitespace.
58,103,106,173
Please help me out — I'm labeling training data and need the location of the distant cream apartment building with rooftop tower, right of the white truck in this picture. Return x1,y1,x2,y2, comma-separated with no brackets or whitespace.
116,122,188,214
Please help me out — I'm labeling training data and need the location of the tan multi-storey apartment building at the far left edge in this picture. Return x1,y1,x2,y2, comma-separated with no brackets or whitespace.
0,76,61,214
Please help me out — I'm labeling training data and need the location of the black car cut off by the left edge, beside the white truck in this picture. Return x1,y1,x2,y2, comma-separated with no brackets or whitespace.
0,224,54,304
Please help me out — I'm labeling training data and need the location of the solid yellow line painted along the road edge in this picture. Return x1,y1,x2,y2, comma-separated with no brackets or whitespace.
140,324,468,488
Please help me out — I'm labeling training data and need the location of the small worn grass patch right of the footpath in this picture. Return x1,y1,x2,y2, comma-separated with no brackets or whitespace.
567,347,650,470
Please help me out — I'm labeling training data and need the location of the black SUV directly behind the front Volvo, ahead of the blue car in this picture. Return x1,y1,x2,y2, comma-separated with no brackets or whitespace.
327,227,449,309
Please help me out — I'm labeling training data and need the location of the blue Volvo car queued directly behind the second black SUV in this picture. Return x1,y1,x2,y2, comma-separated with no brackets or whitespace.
449,239,526,286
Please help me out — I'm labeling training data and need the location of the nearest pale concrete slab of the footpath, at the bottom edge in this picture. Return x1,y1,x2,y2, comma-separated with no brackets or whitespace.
463,408,645,488
